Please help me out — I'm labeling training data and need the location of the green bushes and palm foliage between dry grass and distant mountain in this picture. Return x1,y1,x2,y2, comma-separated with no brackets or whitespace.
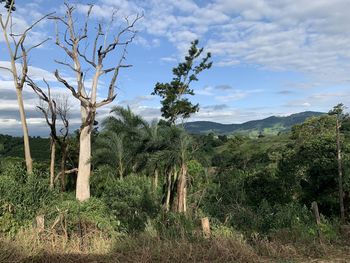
0,103,350,262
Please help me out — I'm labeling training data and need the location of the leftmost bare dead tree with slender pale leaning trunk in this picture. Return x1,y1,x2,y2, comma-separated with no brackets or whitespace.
0,0,53,174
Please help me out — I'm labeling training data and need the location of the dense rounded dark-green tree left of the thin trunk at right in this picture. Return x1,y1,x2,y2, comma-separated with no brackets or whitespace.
279,115,339,215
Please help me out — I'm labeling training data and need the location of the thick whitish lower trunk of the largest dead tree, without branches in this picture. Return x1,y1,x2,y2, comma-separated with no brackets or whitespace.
76,126,91,201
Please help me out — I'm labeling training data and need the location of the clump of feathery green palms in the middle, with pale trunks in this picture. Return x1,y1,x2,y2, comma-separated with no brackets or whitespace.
94,107,192,212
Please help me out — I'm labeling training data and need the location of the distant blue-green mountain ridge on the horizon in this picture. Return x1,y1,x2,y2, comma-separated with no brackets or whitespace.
185,111,325,136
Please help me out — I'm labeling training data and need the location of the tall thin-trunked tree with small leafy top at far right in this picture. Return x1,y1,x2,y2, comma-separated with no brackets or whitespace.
328,103,349,223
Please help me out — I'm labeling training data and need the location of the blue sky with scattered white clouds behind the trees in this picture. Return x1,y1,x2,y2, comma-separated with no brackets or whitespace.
0,0,350,136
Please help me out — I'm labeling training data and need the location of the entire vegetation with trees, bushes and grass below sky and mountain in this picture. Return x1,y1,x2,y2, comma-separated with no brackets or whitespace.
0,0,350,262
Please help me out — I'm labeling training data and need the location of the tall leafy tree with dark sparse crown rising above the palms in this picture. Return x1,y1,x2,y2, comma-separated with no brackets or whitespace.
152,40,212,213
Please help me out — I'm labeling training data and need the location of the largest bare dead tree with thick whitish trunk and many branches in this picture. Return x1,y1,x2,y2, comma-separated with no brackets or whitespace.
51,2,142,201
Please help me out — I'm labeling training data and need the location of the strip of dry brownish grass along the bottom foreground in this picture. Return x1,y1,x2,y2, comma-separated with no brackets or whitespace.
0,229,350,263
